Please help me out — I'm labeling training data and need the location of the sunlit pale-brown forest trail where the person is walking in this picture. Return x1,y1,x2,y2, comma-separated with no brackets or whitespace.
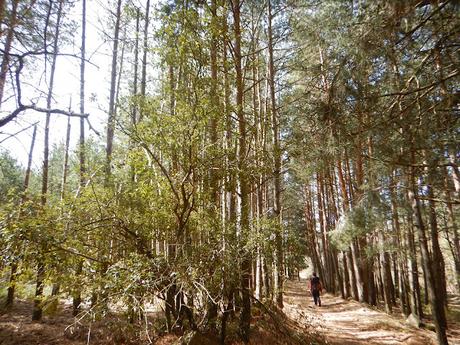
283,279,460,345
